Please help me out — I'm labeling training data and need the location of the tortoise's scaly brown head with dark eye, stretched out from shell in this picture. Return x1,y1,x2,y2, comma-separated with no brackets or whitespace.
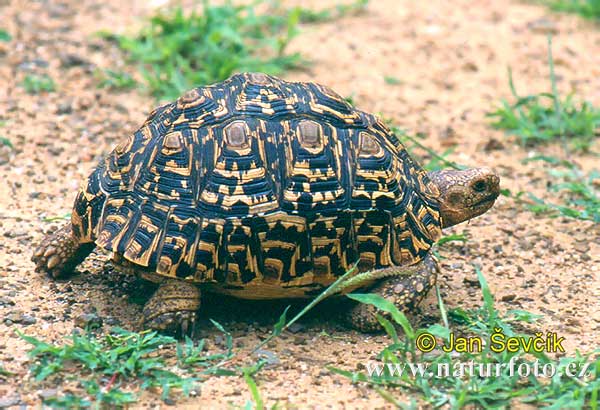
428,168,500,228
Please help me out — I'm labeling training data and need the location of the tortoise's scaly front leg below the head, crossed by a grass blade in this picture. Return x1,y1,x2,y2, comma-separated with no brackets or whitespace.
346,253,439,332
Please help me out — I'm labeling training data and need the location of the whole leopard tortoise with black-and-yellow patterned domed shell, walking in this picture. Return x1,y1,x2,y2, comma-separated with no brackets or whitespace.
32,73,499,332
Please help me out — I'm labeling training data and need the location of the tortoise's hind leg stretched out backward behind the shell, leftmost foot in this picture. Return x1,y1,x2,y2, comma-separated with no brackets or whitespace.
31,222,96,279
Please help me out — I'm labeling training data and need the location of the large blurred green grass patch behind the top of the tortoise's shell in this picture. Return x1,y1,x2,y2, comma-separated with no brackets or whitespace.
101,0,367,100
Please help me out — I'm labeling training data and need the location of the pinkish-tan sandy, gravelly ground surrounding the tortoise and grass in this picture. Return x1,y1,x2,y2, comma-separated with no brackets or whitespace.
0,0,600,408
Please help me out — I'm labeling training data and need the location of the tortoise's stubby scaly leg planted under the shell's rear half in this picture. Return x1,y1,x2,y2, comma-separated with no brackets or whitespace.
142,279,200,335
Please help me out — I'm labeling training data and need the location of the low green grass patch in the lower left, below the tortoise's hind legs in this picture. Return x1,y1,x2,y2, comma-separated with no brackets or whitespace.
18,328,238,407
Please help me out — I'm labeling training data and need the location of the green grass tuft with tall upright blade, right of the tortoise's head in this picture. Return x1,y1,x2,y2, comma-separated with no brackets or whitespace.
487,37,600,151
